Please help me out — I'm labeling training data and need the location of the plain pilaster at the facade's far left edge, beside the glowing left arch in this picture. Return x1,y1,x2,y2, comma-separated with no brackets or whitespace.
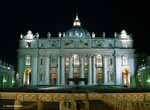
18,55,25,86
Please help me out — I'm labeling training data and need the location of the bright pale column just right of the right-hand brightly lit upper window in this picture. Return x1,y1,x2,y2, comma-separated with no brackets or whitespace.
104,55,108,85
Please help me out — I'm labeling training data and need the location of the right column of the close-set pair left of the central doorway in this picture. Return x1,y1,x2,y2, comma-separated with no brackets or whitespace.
61,56,65,85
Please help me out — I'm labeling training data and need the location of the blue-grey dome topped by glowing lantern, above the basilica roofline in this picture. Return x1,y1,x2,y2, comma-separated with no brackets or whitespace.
65,15,91,38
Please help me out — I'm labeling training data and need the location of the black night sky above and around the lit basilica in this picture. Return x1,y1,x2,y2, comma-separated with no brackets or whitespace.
0,0,150,69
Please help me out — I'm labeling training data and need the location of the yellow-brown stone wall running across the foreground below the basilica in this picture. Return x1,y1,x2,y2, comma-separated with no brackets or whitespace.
0,92,150,110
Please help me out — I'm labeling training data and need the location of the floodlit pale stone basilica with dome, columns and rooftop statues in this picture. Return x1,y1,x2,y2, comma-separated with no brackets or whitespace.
18,16,135,86
